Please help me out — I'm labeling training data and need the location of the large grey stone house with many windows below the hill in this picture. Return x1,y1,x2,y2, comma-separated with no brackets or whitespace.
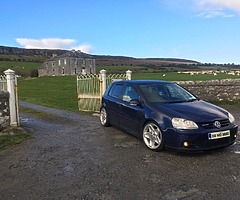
38,50,96,77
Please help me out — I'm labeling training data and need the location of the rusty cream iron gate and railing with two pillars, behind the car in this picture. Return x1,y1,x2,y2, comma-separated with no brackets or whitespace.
77,70,132,112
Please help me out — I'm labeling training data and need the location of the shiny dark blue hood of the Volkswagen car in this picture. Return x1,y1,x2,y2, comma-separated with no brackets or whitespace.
154,100,228,122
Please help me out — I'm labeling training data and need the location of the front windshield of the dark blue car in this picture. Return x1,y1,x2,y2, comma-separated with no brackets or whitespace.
139,83,196,103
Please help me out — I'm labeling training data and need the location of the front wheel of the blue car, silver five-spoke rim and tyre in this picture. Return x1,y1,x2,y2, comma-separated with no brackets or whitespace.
142,122,164,151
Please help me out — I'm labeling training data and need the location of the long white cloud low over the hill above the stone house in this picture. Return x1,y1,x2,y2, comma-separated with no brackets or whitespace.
16,38,93,53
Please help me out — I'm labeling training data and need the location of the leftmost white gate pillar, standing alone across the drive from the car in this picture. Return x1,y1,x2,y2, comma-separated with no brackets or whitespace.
4,69,18,126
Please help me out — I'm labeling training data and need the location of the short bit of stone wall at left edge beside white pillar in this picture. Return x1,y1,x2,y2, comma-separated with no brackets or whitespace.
0,92,10,131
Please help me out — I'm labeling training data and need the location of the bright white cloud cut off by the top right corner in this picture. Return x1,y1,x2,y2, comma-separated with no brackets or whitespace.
195,0,240,12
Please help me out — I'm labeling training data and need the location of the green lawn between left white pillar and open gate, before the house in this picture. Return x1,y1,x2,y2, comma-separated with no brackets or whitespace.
18,76,78,111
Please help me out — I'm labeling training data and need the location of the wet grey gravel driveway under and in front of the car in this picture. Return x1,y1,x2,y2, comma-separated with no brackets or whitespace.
0,102,240,200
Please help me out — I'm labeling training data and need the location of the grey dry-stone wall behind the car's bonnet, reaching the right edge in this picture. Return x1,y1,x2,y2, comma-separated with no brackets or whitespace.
177,79,240,101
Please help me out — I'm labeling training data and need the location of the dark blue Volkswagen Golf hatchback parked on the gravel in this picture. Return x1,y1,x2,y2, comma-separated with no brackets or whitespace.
100,80,238,151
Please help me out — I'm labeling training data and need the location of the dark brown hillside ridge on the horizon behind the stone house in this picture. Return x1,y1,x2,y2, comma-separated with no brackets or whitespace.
0,46,199,67
